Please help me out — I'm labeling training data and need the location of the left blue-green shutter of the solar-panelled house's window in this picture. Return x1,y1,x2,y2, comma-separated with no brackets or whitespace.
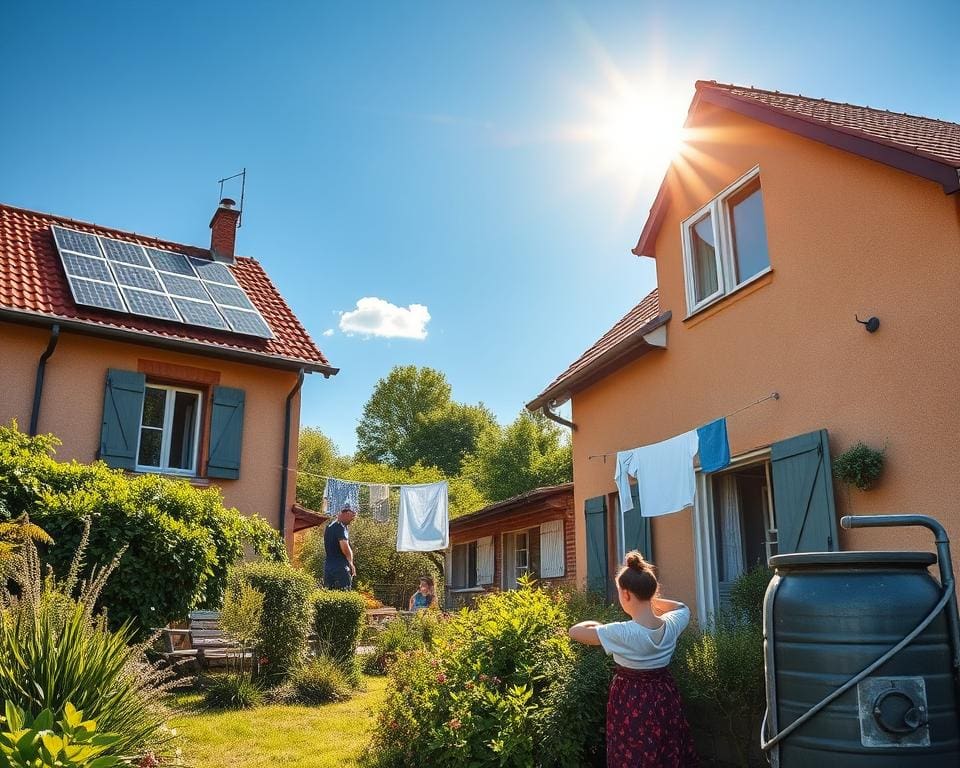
100,368,147,469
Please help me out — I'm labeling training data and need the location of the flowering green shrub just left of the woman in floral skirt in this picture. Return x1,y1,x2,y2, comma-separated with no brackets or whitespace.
364,583,583,768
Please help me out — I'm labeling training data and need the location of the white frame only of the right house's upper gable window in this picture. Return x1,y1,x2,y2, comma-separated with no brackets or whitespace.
680,165,771,317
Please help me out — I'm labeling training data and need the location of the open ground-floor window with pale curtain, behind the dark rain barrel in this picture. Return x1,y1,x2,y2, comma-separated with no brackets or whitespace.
708,462,777,608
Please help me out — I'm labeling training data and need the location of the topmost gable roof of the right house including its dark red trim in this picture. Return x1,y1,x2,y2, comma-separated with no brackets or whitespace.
633,80,960,256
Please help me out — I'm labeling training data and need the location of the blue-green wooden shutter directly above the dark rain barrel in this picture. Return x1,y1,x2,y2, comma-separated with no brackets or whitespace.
770,429,837,554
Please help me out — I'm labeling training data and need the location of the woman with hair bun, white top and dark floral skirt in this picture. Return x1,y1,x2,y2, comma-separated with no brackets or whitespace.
570,552,699,768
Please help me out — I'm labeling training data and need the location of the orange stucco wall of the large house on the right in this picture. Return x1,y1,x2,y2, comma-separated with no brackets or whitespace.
573,105,960,616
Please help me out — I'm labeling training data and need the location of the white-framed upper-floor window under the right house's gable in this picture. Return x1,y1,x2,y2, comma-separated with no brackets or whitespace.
683,168,770,314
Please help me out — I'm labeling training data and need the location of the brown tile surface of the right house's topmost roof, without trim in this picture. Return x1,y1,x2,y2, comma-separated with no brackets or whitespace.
697,80,960,168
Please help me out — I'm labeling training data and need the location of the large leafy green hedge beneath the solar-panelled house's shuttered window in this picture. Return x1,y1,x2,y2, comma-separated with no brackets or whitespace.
0,423,286,635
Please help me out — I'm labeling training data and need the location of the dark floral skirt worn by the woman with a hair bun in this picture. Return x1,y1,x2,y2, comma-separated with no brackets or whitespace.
607,666,700,768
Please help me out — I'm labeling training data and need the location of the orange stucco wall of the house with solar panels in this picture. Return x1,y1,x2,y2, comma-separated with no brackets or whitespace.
0,322,300,546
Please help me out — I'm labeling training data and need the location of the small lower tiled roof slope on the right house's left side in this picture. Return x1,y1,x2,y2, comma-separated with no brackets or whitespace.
527,288,669,411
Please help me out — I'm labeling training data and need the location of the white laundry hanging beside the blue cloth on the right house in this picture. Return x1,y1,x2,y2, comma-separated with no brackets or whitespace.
614,430,699,517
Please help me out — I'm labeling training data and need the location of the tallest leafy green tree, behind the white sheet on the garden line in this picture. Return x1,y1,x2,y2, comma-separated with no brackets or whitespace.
357,365,450,467
